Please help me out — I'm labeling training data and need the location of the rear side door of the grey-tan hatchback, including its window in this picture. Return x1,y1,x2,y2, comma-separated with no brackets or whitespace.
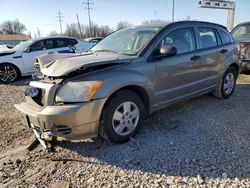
197,26,227,89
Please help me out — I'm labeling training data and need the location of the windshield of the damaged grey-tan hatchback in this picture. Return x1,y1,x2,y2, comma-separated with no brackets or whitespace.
90,27,160,55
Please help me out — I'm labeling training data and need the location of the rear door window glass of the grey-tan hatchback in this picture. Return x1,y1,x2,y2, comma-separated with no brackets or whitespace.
198,27,218,49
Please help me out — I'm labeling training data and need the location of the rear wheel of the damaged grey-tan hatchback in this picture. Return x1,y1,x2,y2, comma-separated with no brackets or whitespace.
213,67,238,99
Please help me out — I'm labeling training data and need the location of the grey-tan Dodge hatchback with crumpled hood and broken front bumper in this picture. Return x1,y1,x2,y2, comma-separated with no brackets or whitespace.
15,21,239,147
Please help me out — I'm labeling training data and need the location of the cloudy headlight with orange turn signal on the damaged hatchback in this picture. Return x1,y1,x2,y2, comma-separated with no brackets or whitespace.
56,81,103,102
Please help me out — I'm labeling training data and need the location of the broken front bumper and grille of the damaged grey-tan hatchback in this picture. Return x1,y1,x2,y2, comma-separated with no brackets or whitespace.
15,80,106,147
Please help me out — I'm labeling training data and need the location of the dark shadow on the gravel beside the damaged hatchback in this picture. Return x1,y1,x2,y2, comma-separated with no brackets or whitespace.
50,84,250,178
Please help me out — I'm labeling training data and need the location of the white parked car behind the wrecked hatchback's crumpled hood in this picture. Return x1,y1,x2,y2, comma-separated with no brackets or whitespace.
0,37,93,83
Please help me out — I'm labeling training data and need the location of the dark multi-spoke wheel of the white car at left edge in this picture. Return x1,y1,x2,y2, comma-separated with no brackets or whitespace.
0,64,20,84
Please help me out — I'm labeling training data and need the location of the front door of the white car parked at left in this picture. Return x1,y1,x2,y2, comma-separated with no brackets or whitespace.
22,39,55,73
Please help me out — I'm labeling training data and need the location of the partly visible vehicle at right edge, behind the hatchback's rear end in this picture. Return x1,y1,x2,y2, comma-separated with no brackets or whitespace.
231,22,250,71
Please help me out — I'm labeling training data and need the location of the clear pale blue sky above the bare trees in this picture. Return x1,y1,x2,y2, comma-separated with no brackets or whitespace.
0,0,250,36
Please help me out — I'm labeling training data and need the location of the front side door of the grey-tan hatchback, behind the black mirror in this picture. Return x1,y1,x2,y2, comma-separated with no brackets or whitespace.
151,27,204,106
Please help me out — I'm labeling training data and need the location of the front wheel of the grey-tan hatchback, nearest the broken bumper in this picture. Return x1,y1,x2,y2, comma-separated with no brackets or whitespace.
99,90,145,143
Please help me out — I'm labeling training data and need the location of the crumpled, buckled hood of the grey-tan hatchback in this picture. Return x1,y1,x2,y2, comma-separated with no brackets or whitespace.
41,53,134,77
